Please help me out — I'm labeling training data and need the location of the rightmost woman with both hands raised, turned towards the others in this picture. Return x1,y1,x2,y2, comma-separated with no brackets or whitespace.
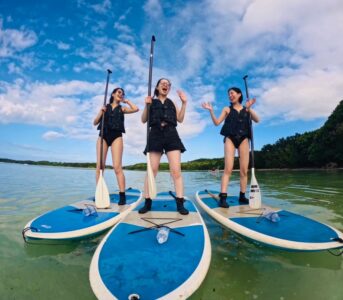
202,87,259,208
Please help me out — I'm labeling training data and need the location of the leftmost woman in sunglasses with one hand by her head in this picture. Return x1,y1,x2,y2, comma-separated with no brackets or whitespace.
93,88,138,205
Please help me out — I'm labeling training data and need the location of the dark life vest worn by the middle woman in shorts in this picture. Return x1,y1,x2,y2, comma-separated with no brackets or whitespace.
149,98,177,127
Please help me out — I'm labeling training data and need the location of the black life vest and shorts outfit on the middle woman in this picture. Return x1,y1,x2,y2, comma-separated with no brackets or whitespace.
144,98,186,154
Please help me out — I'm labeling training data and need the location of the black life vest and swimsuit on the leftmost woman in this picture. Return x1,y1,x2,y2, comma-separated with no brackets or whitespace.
98,104,125,147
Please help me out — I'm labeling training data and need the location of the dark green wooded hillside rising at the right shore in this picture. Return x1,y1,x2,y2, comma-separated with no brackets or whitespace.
255,100,343,169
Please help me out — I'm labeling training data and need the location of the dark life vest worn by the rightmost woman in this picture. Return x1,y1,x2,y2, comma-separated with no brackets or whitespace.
220,106,250,138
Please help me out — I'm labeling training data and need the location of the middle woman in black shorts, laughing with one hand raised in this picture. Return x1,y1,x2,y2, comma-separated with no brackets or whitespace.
139,78,188,215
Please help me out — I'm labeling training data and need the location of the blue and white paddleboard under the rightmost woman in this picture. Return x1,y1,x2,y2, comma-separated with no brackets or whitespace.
196,190,343,251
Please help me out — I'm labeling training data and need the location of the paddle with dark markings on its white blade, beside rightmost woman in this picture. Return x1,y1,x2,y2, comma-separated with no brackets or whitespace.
243,75,262,208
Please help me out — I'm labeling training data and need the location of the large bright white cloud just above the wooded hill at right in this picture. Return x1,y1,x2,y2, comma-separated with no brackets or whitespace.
254,70,343,121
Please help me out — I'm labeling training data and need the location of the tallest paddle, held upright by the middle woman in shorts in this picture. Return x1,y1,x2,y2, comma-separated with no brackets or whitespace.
146,35,156,199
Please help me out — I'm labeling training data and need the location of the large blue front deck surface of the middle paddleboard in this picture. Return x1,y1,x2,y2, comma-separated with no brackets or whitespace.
98,223,204,299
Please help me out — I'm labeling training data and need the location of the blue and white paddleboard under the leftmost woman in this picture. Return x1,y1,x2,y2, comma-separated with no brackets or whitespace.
22,188,142,242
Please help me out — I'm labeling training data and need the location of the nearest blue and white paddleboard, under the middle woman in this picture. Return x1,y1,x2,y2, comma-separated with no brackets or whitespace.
89,193,211,300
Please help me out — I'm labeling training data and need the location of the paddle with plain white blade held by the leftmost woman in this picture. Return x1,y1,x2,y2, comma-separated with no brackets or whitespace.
95,69,112,208
